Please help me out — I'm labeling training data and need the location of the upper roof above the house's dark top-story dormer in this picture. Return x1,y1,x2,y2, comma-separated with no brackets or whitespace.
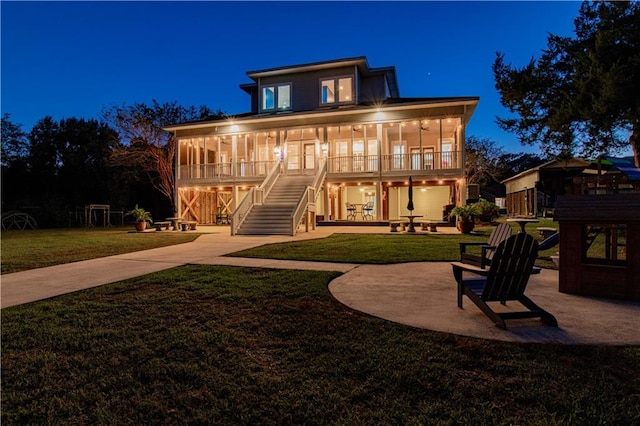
240,56,400,98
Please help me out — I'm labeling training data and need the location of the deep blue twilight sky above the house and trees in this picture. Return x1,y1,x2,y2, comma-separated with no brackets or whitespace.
1,1,580,152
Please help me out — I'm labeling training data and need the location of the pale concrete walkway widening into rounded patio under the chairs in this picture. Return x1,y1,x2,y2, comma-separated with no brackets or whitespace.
0,227,640,345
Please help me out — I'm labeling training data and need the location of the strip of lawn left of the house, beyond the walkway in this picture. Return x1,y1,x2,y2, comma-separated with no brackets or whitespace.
1,227,201,274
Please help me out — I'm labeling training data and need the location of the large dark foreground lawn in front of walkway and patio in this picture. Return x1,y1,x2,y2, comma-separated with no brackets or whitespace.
1,266,640,425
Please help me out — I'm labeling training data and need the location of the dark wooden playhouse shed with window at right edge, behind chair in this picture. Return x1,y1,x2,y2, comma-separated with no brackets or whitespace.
554,192,640,301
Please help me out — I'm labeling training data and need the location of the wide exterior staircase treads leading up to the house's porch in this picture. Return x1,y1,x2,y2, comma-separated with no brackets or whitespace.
237,175,314,235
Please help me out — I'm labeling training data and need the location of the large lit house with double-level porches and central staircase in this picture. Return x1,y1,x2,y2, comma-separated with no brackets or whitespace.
167,57,479,234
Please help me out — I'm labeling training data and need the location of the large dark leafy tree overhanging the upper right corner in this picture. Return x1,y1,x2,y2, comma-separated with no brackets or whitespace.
493,2,640,167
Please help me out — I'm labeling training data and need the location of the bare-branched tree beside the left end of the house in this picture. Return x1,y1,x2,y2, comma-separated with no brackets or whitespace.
103,99,224,210
